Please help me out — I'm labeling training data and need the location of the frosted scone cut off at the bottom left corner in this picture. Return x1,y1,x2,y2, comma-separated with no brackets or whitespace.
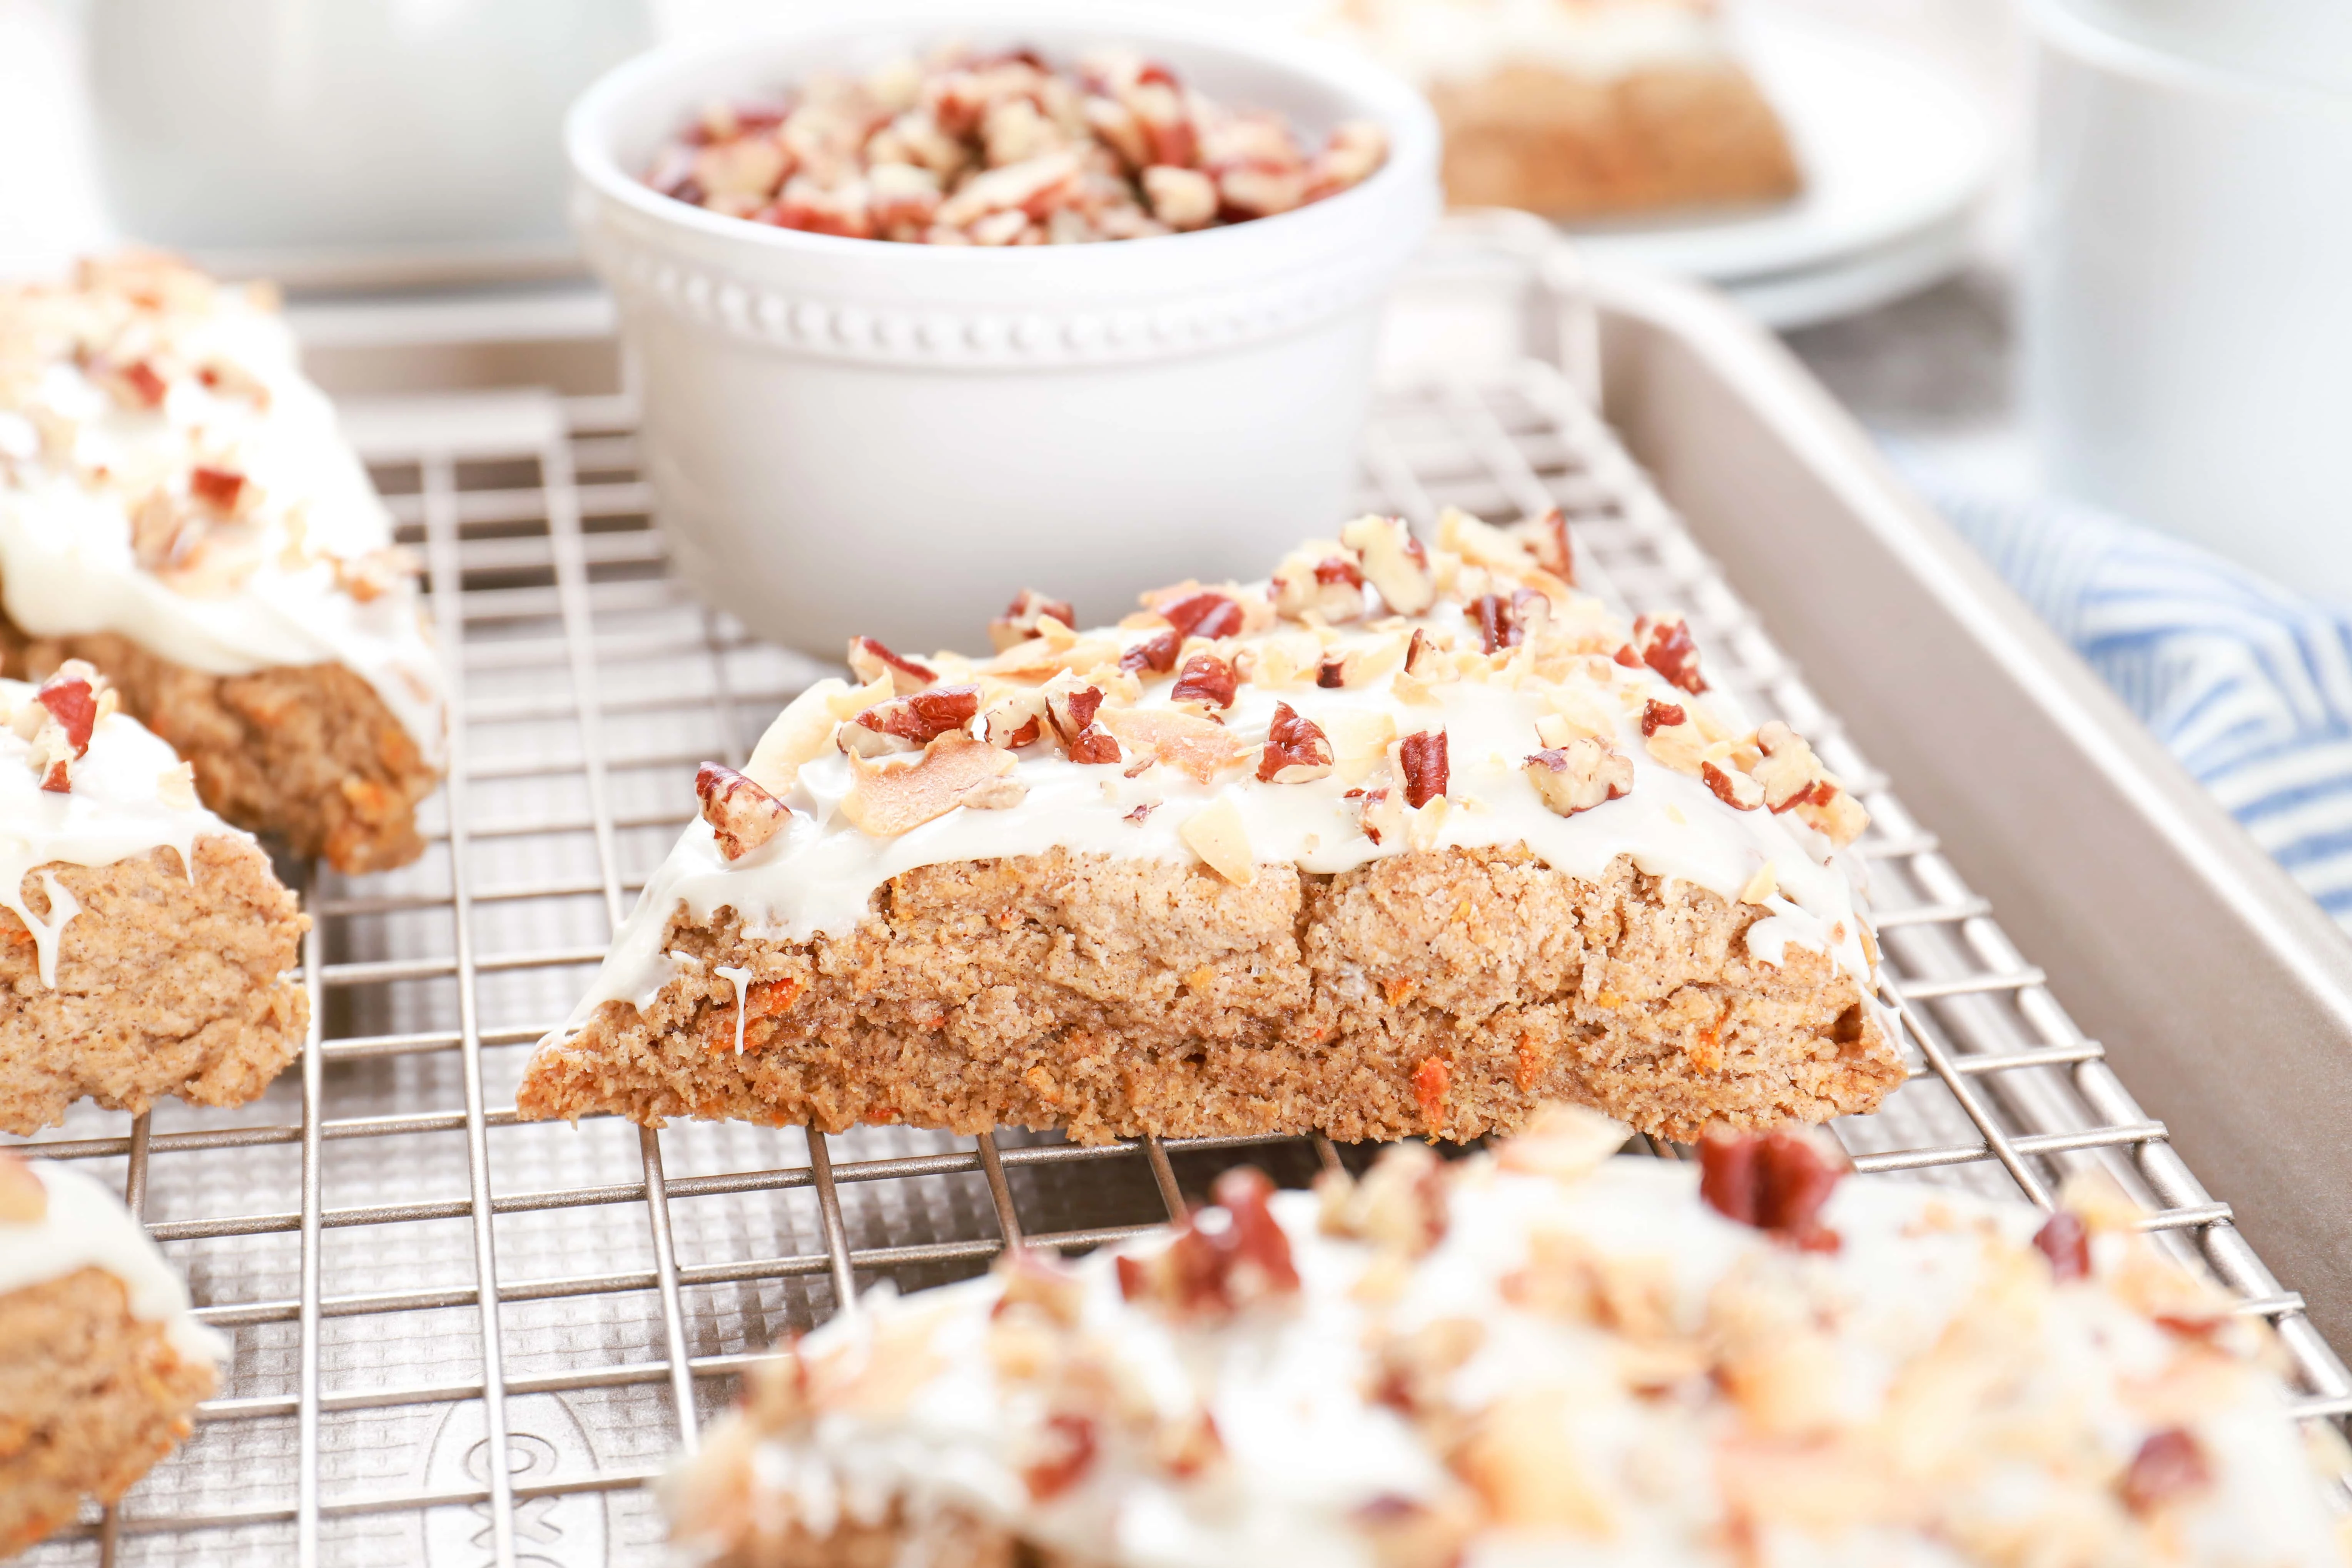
0,1150,228,1556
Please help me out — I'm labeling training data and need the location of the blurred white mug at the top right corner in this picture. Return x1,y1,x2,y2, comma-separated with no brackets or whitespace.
2023,0,2352,604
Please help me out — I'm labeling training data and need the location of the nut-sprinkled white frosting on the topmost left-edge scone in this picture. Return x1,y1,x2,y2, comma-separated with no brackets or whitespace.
0,259,447,766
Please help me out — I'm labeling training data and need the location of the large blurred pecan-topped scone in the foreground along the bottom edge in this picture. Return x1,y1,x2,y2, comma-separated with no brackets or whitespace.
666,1110,2352,1568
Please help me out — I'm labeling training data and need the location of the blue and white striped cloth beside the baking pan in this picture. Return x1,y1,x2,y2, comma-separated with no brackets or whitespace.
1898,472,2352,931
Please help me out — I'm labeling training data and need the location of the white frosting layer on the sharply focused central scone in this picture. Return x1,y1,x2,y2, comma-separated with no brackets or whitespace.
567,513,1874,1027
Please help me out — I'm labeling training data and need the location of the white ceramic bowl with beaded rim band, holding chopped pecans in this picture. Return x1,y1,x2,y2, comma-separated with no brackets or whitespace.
565,0,1440,658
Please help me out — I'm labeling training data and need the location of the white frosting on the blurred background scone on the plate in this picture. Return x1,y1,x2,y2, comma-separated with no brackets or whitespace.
1322,0,1729,85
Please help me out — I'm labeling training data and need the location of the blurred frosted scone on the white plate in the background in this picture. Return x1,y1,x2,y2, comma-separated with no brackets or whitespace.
1334,0,1802,219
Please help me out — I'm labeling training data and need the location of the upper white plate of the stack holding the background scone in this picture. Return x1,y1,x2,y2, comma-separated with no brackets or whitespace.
1571,12,1995,284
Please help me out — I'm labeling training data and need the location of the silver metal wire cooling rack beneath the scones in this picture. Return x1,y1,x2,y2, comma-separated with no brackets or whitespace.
28,334,2352,1568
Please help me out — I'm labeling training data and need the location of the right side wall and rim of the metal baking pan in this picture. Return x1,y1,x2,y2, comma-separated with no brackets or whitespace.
1571,273,2352,1345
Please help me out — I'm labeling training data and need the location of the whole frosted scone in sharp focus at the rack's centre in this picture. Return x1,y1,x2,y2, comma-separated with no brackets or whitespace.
518,513,1903,1140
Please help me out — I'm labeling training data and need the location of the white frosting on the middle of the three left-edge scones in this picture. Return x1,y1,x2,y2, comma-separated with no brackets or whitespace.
0,680,236,985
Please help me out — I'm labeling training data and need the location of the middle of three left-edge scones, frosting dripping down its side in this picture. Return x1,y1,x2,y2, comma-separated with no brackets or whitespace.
0,663,311,1133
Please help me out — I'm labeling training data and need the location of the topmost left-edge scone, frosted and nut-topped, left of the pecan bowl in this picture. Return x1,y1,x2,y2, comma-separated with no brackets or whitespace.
0,256,444,872
